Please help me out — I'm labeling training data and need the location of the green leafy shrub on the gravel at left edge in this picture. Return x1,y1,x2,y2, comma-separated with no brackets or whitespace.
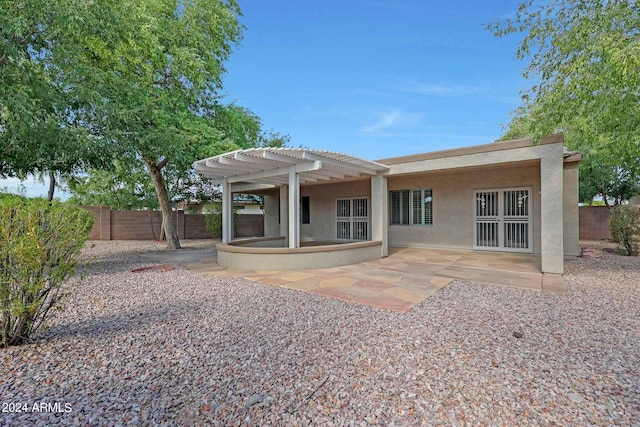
0,195,93,347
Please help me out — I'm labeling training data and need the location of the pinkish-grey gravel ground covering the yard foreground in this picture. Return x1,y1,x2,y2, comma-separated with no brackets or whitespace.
0,242,640,426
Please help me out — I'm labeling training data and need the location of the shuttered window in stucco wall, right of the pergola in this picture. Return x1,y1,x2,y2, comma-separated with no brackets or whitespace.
390,189,433,225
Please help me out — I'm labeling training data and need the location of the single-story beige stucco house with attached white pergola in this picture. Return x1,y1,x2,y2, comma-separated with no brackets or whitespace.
194,135,582,280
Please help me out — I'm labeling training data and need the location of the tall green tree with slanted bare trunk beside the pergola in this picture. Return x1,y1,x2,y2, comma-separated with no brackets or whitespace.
56,0,242,249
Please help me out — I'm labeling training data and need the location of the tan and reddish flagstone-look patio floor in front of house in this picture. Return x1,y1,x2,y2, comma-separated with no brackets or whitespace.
145,247,567,312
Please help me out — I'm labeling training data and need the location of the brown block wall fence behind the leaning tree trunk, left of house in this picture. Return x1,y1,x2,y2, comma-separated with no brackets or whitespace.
80,206,264,240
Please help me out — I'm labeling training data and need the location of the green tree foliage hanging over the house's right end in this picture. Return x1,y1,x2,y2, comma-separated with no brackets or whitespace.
488,0,640,206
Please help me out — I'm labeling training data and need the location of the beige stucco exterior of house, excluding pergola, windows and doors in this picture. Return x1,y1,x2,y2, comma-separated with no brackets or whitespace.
256,141,579,274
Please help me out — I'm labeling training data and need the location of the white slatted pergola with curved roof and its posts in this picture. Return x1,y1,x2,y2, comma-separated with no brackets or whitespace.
193,147,389,248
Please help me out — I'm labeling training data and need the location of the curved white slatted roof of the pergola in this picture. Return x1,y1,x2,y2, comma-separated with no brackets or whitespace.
193,147,389,185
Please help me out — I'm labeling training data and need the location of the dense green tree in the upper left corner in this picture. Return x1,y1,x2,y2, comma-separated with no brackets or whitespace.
0,0,109,200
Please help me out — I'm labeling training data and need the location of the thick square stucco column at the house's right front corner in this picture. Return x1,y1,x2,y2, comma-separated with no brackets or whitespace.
540,152,564,274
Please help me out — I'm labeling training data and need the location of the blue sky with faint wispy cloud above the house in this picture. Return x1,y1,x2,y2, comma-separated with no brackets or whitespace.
0,0,527,195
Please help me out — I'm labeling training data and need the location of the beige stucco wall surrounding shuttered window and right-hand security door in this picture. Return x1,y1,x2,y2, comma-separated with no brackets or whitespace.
387,162,540,253
